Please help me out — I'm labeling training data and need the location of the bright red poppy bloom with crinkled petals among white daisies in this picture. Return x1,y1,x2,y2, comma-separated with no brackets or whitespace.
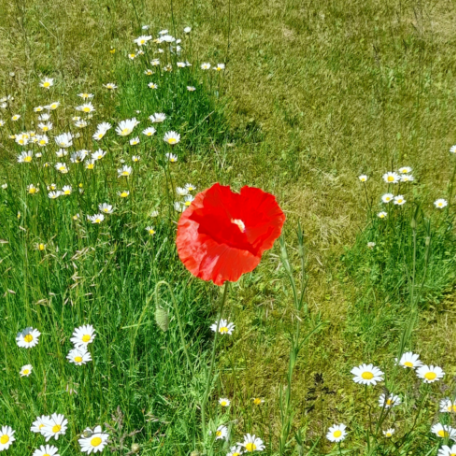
176,184,285,285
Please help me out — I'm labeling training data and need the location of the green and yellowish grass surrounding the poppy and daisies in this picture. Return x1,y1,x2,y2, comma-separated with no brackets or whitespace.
0,0,456,454
